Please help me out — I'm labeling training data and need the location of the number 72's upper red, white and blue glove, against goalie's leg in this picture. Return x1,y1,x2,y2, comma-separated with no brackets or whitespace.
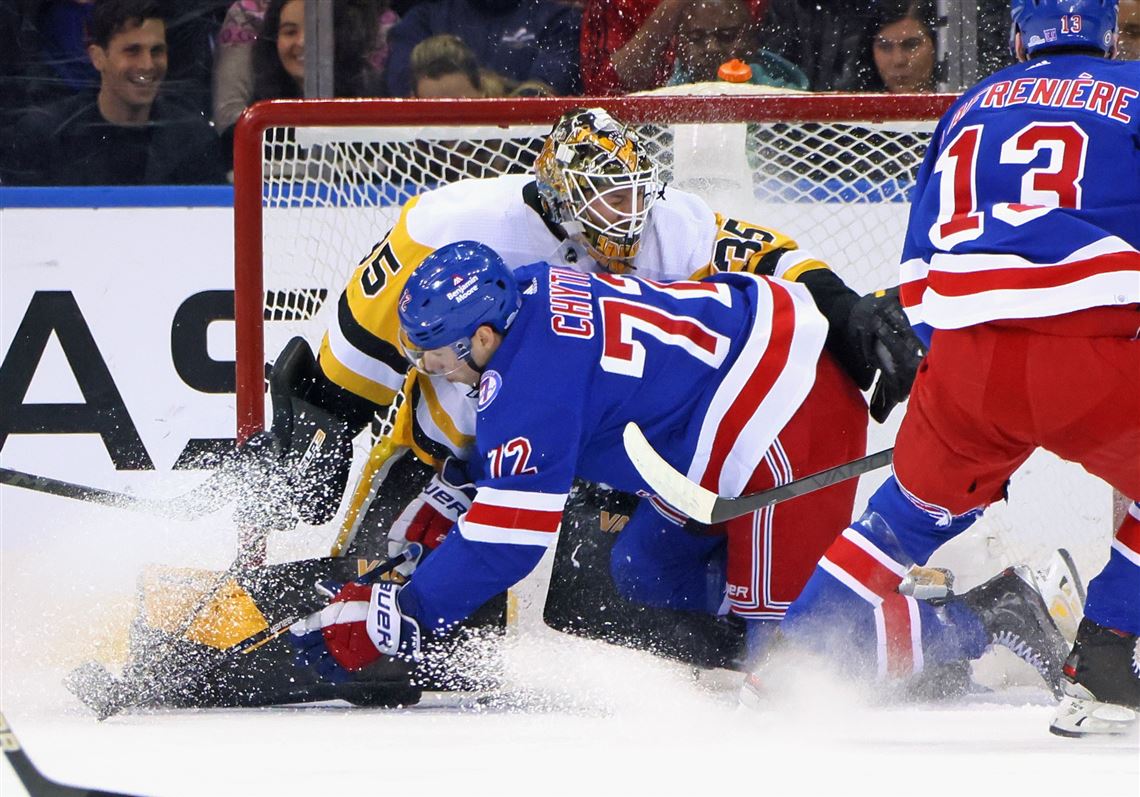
388,456,475,576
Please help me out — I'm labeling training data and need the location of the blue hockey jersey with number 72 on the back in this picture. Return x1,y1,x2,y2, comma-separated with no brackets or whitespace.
400,263,828,628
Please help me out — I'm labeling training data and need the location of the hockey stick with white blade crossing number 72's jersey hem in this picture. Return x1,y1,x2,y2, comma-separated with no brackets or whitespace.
621,422,895,523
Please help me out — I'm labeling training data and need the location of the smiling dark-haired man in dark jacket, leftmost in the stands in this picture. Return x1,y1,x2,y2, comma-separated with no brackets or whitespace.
2,0,225,185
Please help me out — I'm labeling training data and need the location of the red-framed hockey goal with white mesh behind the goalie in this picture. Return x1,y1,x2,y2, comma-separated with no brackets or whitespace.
235,95,1112,592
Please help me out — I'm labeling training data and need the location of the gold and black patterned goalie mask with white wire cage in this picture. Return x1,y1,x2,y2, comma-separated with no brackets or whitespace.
535,108,663,274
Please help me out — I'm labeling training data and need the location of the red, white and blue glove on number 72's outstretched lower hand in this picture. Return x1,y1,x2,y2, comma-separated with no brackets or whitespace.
290,582,420,683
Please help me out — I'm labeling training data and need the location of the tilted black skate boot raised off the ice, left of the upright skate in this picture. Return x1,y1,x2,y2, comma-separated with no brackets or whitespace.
951,564,1068,700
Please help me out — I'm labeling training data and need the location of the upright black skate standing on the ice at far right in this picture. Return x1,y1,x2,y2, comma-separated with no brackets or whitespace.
1049,618,1140,737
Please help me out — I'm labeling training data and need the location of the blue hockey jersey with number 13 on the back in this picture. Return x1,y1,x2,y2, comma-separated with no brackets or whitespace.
901,55,1140,328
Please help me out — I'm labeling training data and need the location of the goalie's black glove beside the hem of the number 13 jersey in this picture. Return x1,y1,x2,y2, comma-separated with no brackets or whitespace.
847,288,926,423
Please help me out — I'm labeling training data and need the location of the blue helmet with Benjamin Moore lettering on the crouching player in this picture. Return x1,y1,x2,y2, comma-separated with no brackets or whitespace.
398,241,522,374
